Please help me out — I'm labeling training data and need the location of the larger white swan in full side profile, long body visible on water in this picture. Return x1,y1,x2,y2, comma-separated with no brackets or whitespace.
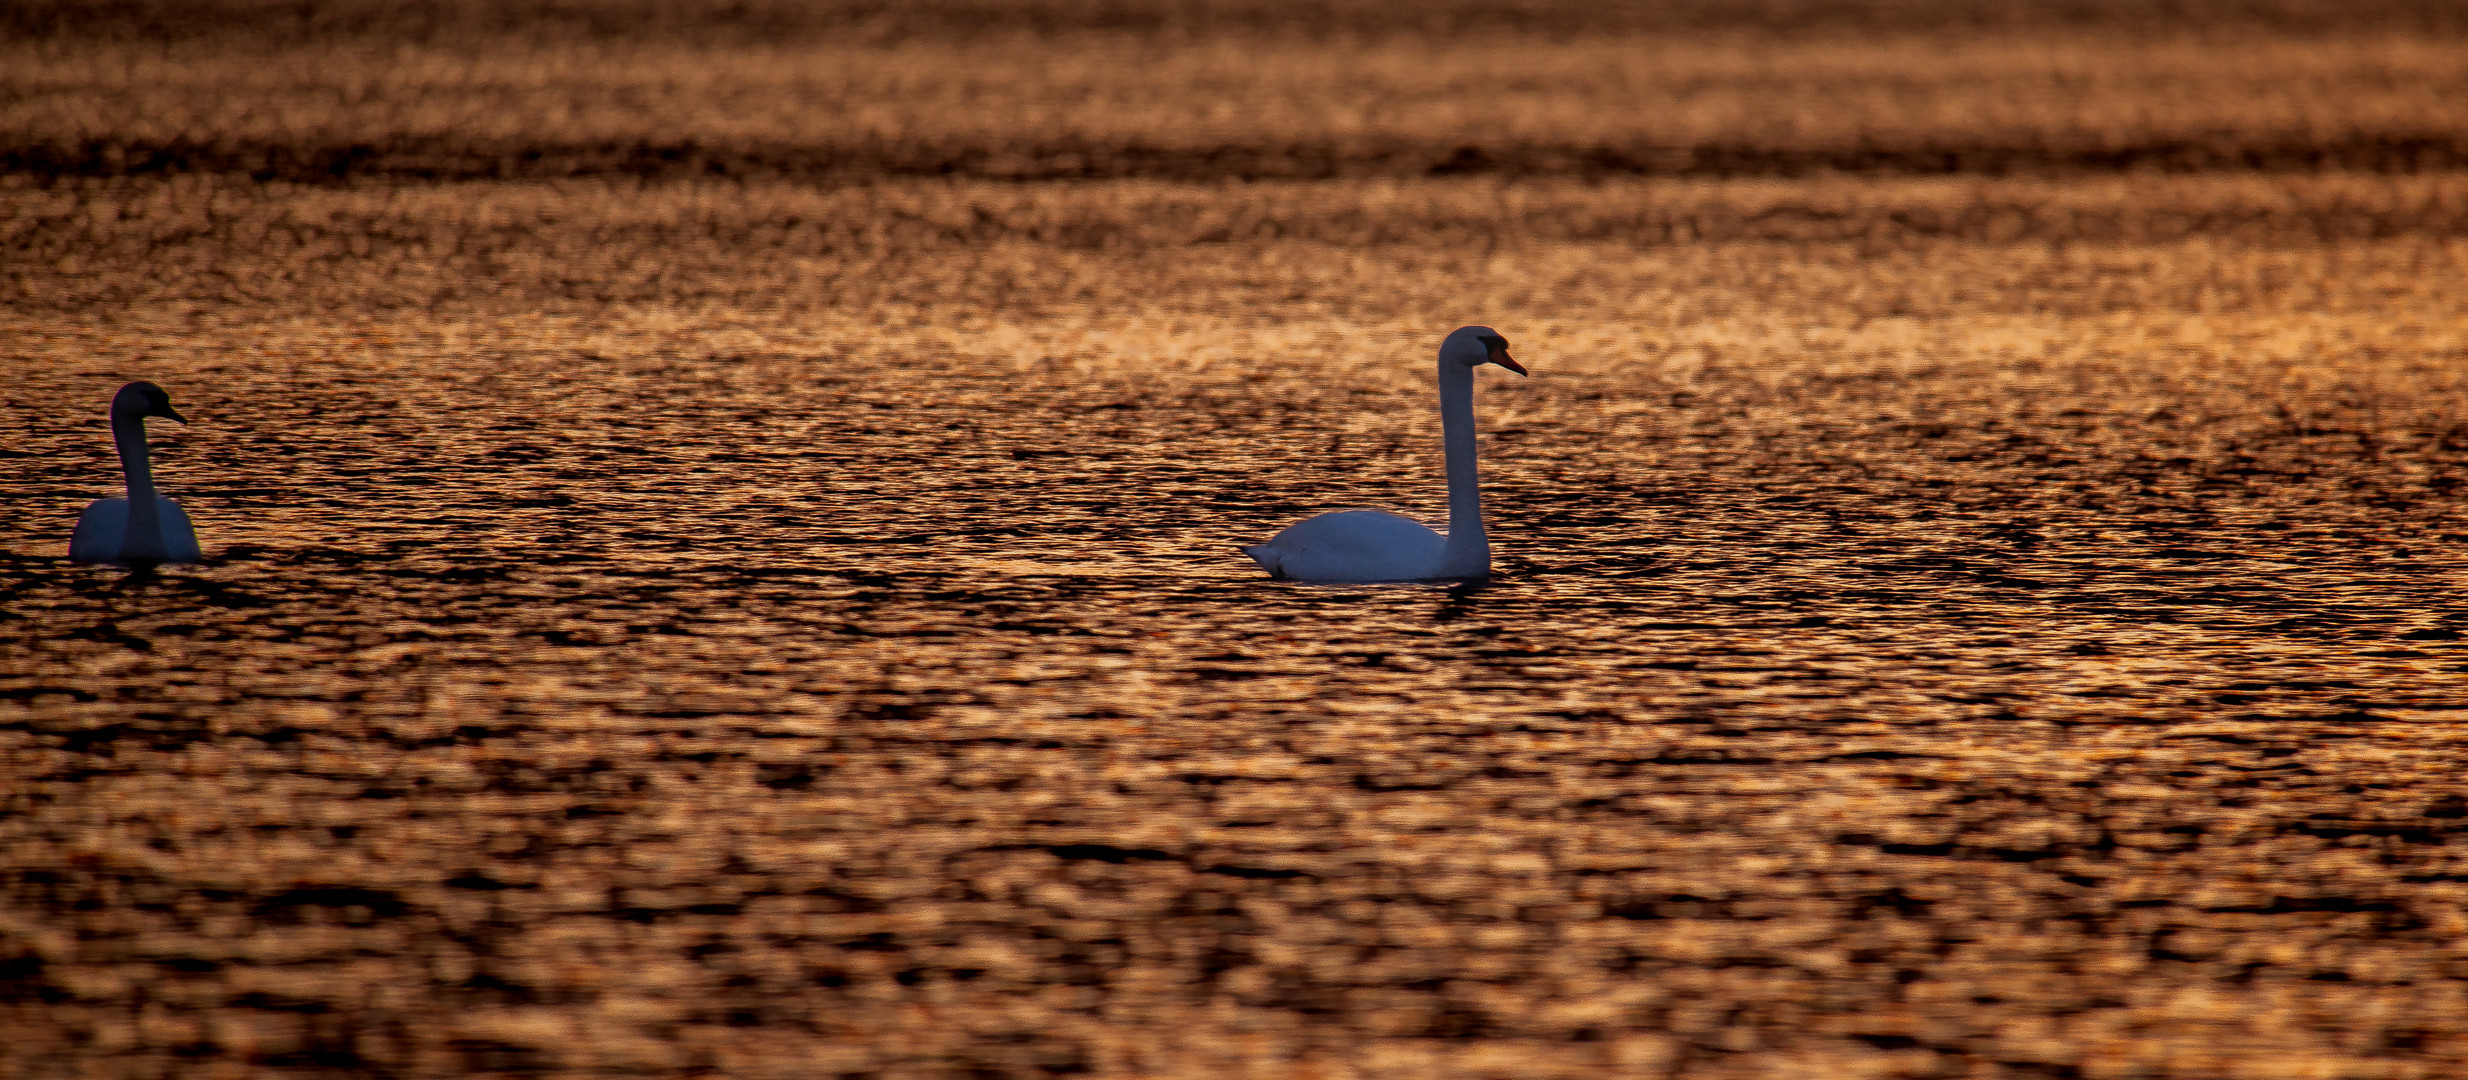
1244,325,1525,582
